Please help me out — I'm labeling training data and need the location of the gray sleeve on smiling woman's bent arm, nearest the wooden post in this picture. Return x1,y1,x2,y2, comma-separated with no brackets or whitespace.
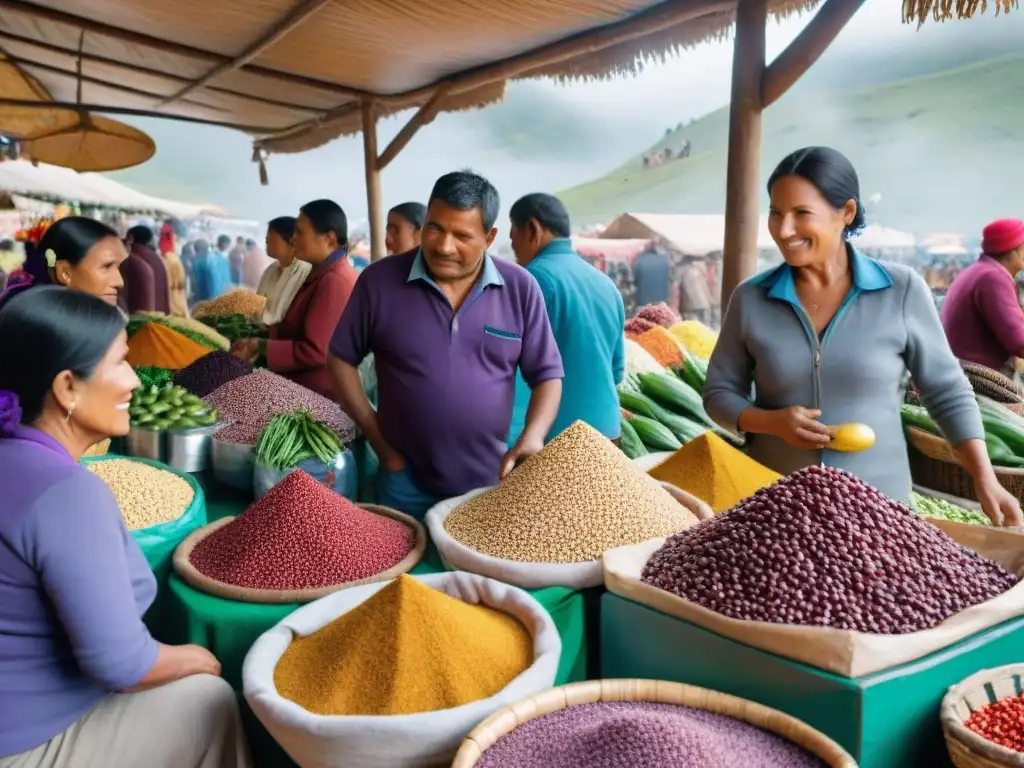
703,286,754,434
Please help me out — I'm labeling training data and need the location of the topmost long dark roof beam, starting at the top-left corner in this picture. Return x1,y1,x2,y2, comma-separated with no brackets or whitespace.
0,0,373,97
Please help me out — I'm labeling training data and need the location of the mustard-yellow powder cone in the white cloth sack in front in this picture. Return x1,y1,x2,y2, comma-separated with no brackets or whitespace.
273,575,534,715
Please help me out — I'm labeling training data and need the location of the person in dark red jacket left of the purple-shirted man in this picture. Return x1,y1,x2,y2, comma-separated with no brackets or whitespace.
232,200,357,399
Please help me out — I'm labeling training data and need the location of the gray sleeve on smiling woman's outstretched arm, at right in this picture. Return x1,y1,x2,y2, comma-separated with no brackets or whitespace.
903,270,985,445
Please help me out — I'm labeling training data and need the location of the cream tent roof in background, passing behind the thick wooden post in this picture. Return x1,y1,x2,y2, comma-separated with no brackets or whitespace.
601,213,777,256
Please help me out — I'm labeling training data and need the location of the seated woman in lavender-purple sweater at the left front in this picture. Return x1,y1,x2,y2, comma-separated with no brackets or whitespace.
0,287,250,768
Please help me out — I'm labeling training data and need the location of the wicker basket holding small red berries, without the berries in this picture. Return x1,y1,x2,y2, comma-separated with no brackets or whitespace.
940,664,1024,768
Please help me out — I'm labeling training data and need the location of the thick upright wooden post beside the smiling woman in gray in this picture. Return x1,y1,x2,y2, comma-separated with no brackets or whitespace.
722,0,768,309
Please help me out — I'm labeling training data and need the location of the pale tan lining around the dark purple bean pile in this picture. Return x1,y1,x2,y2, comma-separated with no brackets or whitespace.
604,524,1024,678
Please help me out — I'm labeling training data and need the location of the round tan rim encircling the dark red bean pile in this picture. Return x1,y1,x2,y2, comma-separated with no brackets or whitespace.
174,504,427,604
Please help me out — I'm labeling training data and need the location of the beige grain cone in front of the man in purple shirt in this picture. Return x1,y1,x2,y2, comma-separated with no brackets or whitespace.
444,421,696,562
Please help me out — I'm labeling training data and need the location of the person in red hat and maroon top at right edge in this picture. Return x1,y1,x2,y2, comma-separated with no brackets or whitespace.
942,219,1024,376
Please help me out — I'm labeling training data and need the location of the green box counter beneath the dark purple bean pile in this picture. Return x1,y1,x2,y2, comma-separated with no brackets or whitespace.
600,594,1024,768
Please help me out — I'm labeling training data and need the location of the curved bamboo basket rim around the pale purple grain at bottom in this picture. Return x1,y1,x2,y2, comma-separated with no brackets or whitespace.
452,680,857,768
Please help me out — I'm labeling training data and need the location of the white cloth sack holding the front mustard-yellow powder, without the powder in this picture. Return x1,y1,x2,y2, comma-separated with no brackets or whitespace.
242,572,562,768
